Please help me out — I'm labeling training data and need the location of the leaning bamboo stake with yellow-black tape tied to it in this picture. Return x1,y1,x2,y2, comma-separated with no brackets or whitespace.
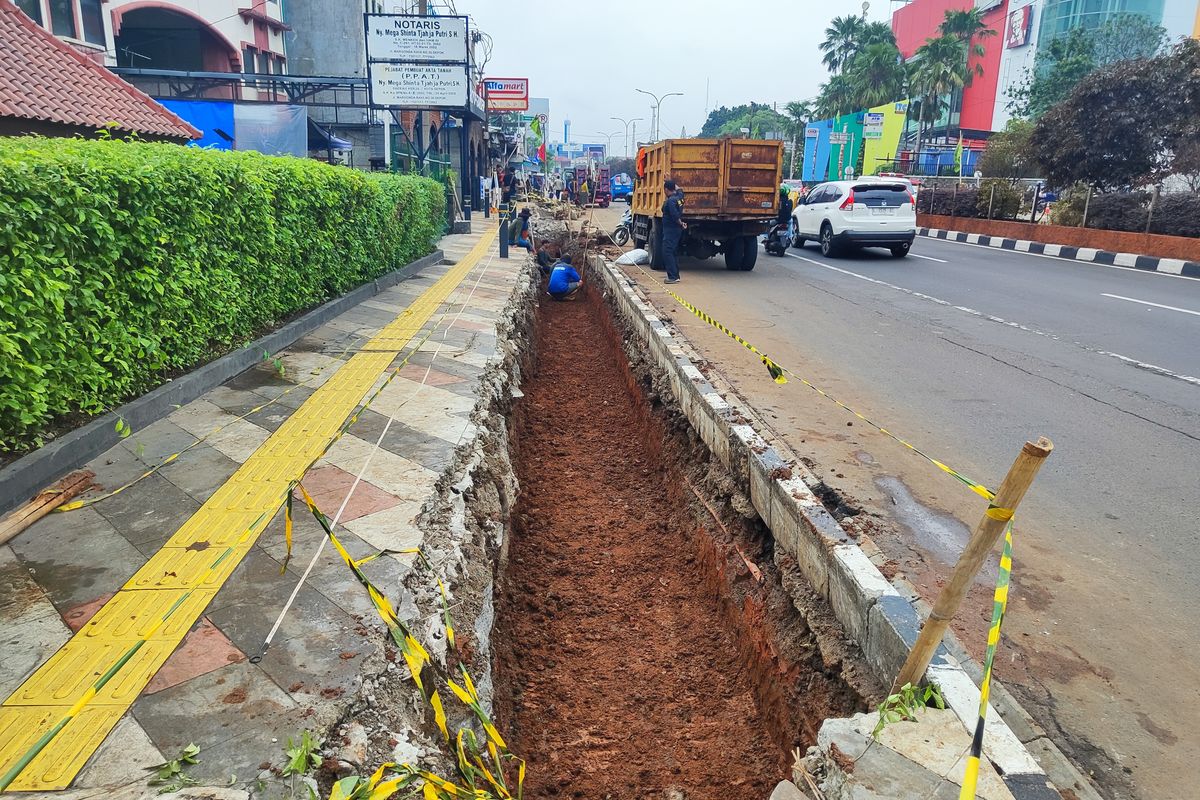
895,437,1054,686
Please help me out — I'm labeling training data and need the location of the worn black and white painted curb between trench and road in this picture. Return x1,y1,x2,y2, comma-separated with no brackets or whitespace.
588,257,1098,800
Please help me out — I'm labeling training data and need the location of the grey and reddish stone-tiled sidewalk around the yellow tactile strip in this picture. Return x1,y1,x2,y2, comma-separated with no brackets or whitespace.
0,223,523,799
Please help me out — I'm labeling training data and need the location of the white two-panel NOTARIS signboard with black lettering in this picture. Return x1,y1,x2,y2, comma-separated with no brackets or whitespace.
362,14,470,110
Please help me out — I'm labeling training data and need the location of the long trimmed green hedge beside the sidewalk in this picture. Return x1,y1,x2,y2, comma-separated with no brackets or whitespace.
0,137,445,451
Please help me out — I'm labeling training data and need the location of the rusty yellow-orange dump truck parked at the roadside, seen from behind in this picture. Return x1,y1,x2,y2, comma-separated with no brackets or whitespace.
632,139,784,270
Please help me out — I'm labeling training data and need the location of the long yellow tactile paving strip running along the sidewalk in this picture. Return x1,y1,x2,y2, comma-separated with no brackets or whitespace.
0,229,496,790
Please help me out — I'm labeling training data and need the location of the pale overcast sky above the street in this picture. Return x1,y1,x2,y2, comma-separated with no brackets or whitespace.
456,0,898,155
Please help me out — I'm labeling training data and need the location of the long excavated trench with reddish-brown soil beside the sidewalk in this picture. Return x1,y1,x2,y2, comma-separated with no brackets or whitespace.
492,257,870,800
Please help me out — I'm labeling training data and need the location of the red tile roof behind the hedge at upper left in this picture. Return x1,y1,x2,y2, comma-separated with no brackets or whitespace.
0,0,200,139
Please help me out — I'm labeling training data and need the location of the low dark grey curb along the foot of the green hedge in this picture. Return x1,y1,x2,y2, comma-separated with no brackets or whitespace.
0,249,445,513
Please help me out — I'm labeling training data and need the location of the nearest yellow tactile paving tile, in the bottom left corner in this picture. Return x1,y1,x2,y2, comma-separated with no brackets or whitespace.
0,705,126,792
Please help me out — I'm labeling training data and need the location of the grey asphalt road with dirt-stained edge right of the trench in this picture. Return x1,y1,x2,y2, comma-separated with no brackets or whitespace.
598,208,1200,798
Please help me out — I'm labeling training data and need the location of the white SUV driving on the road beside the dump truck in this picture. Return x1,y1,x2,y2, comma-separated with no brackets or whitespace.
792,178,917,258
